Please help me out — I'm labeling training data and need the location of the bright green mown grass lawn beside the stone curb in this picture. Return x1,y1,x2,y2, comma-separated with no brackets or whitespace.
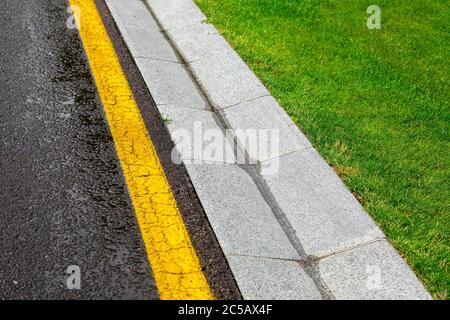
196,0,450,299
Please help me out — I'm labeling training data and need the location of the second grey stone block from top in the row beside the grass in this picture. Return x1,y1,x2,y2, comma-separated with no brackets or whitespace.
168,23,233,62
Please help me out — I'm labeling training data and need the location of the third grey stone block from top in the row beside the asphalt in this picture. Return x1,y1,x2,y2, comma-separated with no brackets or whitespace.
158,105,236,163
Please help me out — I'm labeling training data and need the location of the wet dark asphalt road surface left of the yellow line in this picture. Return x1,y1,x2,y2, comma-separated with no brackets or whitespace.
0,0,158,299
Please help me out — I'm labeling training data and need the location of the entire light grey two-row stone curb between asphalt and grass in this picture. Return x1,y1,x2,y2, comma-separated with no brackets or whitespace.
106,0,431,299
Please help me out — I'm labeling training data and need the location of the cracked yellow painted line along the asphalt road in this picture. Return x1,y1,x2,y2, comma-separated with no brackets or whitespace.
70,0,213,300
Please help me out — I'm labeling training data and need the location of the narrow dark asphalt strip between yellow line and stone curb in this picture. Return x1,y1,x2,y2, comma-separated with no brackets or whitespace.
96,0,241,299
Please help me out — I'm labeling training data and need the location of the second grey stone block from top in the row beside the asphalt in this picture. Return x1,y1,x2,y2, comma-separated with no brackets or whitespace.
135,58,206,109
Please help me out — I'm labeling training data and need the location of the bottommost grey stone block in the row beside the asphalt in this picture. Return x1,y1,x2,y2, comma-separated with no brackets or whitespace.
227,256,321,300
